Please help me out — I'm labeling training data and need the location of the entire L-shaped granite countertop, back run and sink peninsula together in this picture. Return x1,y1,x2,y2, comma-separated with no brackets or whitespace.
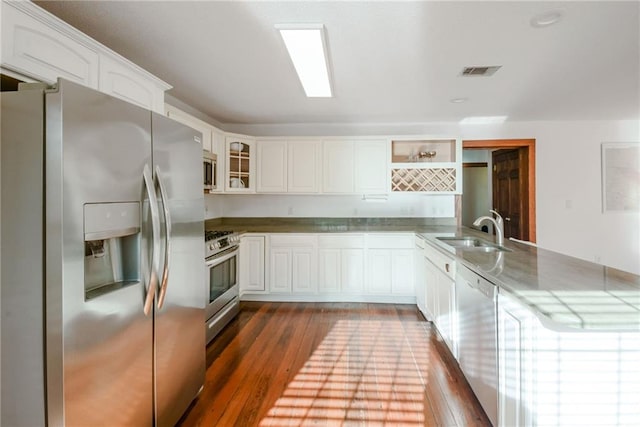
205,218,640,331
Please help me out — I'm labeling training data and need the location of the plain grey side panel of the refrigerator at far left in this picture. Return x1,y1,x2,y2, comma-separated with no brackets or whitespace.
0,90,45,426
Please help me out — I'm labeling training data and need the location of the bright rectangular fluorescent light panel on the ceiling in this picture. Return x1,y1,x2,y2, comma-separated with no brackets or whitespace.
276,24,332,98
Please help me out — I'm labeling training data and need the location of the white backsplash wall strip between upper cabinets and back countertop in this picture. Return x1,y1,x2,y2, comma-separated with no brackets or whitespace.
205,194,455,218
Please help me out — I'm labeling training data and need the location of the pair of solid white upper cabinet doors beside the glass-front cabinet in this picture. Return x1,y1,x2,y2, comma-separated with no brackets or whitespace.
256,139,320,194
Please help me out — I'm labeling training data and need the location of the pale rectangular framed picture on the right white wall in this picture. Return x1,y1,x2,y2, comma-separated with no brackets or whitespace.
601,142,640,213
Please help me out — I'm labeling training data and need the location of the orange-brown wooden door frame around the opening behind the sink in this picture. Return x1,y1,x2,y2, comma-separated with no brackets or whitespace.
462,138,536,243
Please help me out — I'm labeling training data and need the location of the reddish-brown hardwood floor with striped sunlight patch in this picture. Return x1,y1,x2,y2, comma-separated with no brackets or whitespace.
178,302,491,427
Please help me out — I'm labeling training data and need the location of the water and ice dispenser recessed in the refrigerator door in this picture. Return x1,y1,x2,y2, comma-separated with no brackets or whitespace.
84,202,140,300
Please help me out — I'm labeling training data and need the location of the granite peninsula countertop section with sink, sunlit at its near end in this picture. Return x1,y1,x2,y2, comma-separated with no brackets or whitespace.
419,228,640,331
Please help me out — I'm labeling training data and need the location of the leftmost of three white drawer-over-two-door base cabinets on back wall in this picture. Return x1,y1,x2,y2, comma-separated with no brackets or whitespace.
269,234,317,294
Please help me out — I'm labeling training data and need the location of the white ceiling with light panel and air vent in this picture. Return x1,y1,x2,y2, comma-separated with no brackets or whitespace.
37,1,640,124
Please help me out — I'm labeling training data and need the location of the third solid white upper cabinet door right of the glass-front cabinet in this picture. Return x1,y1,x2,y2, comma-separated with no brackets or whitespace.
322,140,355,194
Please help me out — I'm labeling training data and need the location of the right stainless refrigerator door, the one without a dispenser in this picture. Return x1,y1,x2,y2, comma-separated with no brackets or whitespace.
151,113,207,426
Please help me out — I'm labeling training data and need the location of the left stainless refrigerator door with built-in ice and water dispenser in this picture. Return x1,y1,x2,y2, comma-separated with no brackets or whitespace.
45,81,153,426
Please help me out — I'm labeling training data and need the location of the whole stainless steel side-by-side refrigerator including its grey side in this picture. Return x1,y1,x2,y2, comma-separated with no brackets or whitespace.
0,80,206,426
